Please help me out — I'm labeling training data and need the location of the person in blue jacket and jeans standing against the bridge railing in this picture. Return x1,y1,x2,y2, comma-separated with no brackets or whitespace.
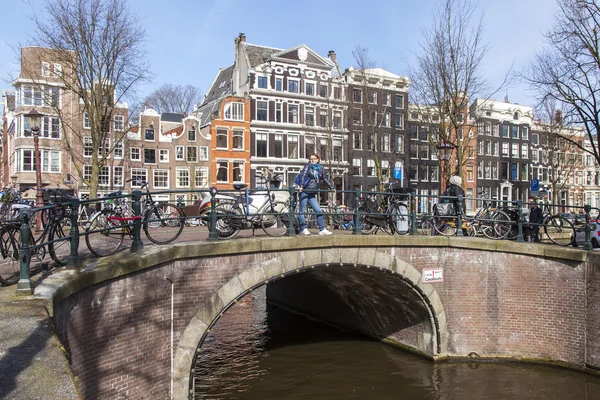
296,154,335,235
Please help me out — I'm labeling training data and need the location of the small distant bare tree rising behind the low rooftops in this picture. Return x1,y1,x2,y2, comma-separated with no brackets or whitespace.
144,83,202,114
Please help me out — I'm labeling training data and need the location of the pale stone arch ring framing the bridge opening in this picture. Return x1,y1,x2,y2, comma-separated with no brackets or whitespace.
173,248,448,398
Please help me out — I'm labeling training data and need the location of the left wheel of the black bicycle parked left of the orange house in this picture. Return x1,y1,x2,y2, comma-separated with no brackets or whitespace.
85,210,126,257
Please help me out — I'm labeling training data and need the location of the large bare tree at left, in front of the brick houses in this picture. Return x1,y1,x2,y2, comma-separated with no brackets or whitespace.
22,0,149,197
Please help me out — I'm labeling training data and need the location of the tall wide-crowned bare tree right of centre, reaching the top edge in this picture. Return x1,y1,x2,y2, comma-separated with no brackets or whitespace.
410,0,488,187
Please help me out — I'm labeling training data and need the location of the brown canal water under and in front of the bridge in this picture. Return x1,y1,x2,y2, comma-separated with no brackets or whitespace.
194,290,600,400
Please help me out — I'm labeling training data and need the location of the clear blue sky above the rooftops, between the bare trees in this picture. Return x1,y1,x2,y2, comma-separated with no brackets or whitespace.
0,0,556,109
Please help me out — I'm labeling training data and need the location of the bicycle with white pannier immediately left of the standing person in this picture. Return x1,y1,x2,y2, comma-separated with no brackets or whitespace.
209,170,290,239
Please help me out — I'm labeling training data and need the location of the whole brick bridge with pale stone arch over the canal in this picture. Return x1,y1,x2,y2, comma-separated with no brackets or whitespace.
35,235,600,399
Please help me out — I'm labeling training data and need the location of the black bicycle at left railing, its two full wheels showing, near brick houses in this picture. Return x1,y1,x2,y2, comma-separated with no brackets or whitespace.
85,180,185,257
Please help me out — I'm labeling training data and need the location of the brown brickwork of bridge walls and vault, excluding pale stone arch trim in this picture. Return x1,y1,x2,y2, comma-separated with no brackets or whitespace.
54,247,600,399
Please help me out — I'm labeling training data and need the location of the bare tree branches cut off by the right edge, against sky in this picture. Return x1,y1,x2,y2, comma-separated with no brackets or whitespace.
523,0,600,163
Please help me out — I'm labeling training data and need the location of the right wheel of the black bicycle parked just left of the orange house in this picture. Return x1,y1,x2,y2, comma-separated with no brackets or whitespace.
143,203,184,244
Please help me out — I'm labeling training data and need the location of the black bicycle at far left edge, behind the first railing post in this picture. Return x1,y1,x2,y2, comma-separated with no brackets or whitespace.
0,204,71,285
